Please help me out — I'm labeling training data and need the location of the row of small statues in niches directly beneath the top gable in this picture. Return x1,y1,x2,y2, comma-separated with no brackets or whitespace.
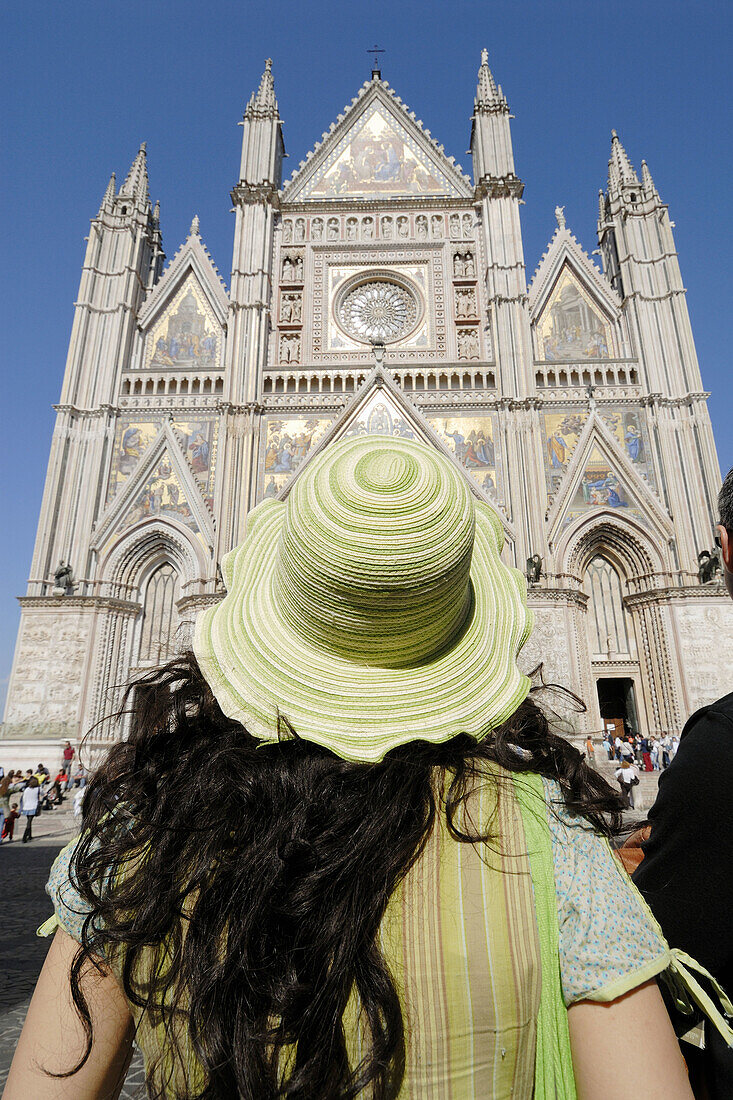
283,213,475,244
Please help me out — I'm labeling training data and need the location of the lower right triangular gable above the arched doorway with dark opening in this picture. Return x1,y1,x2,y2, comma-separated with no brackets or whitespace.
547,410,672,543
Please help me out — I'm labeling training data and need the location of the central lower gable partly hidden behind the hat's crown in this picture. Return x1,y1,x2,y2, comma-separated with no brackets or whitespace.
270,365,515,540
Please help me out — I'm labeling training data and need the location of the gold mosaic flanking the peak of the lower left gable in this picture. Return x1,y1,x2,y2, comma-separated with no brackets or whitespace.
107,417,219,506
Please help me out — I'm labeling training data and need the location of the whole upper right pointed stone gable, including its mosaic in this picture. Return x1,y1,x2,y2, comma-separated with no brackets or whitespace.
529,226,621,362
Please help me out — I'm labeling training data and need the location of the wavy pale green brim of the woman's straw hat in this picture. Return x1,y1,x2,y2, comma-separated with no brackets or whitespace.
194,501,533,762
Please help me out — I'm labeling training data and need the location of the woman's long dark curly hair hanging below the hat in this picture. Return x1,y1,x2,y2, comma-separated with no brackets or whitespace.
61,655,621,1100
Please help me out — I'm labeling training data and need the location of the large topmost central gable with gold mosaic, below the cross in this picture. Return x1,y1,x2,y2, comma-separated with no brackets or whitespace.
283,79,472,202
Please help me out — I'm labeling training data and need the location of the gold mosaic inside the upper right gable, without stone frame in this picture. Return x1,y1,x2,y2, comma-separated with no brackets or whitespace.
537,268,615,360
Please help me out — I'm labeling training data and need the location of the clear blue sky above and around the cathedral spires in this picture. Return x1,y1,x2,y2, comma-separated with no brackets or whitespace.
0,0,733,708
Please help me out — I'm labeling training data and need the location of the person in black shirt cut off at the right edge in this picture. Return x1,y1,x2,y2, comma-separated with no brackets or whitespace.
634,470,733,1100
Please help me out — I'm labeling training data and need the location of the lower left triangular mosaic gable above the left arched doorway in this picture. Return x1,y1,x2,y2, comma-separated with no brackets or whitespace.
94,421,214,548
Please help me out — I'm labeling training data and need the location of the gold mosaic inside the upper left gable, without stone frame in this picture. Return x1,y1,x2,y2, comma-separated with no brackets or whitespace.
145,275,221,371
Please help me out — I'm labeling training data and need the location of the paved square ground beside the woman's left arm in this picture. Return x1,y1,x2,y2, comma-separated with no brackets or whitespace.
0,807,145,1100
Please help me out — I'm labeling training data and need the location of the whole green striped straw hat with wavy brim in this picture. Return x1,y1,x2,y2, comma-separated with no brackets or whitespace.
194,436,532,762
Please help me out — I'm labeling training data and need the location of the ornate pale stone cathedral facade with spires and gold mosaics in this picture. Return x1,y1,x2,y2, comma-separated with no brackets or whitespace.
2,52,733,745
